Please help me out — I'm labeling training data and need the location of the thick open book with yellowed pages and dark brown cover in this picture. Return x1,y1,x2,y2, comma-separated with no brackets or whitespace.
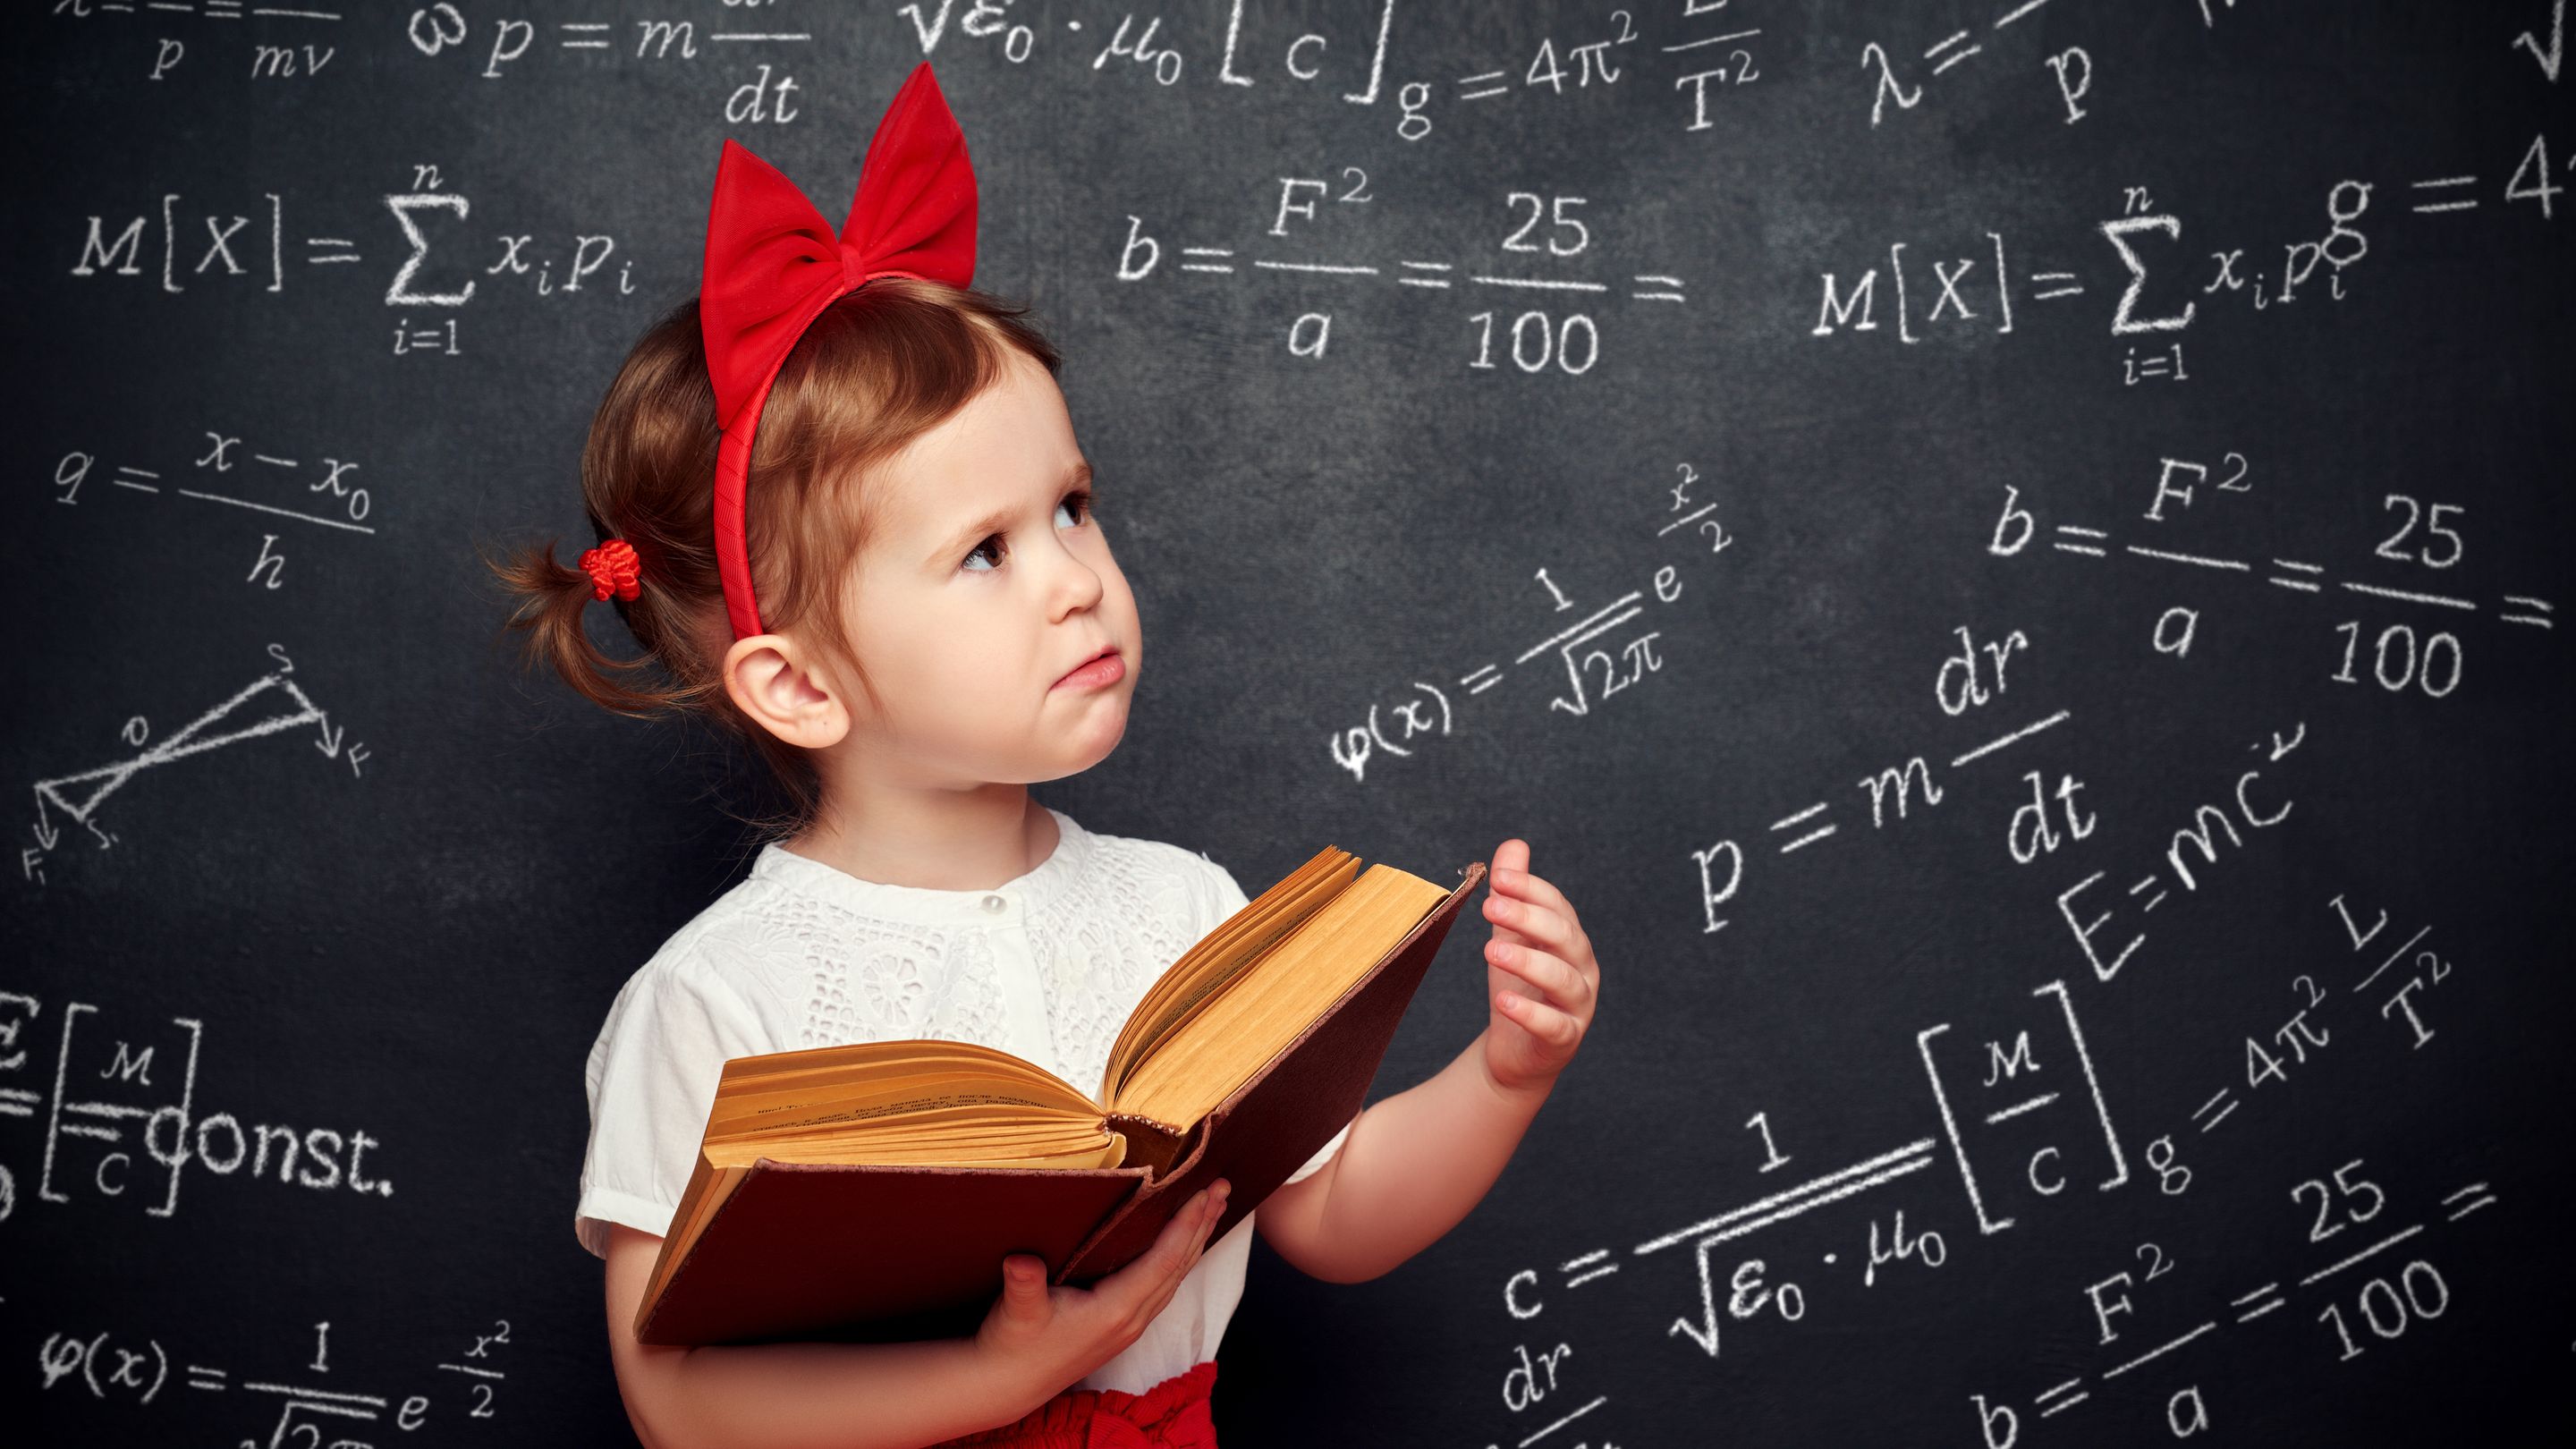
633,845,1484,1343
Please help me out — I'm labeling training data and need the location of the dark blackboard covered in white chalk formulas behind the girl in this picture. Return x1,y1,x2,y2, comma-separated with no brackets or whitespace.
0,0,2576,1449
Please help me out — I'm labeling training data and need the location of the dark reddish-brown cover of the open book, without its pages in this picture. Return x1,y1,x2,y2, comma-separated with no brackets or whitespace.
636,861,1484,1346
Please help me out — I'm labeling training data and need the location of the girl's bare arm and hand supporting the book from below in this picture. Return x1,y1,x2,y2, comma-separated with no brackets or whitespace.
606,1183,1226,1449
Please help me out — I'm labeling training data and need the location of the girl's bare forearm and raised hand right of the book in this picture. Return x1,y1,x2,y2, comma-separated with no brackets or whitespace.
1255,841,1599,1284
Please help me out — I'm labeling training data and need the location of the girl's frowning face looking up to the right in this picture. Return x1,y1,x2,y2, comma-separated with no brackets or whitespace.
845,351,1144,786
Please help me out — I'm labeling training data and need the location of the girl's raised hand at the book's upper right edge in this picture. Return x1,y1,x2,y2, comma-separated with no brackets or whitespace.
1484,841,1602,1090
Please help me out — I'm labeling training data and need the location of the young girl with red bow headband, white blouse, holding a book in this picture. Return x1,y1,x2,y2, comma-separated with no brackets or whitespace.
503,64,1599,1449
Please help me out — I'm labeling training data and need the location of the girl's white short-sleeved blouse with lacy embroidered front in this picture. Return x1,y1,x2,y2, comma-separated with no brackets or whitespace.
572,809,1350,1393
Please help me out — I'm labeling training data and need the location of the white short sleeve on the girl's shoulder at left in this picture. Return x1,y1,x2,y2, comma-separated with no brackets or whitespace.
572,964,767,1258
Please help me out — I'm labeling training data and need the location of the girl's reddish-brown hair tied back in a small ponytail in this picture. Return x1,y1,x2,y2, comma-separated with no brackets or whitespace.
484,275,1062,830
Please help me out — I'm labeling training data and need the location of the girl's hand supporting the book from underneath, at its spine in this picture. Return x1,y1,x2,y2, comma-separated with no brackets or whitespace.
977,1178,1232,1408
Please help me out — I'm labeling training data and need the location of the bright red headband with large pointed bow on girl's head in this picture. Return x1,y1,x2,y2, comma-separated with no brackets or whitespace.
698,62,977,640
